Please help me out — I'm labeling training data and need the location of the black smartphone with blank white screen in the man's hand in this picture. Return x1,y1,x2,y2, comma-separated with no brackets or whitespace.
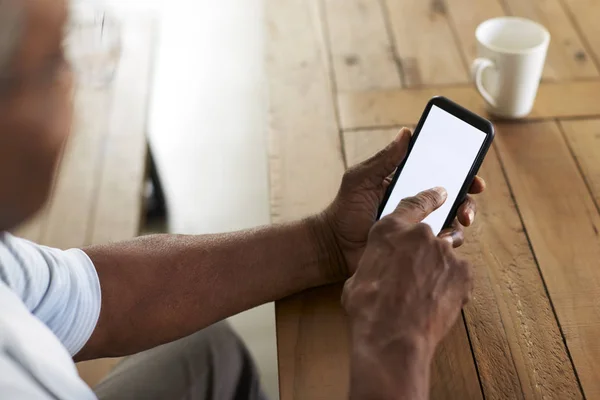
377,97,494,235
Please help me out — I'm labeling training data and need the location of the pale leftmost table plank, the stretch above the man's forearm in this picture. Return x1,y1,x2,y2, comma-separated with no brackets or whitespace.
266,0,344,222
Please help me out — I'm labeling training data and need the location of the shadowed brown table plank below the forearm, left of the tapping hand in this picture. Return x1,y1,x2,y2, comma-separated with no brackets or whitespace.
276,285,350,400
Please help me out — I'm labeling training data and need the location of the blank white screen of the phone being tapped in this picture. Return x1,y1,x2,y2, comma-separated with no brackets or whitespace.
381,106,486,235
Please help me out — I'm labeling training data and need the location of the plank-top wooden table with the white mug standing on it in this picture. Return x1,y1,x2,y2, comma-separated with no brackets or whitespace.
266,0,600,400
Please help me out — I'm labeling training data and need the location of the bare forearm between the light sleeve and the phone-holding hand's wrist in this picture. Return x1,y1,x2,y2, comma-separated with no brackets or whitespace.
76,219,339,360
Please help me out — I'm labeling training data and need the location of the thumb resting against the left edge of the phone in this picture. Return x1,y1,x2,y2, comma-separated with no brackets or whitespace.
361,128,412,180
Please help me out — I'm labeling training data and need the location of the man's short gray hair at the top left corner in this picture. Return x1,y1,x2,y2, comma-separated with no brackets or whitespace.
0,0,23,77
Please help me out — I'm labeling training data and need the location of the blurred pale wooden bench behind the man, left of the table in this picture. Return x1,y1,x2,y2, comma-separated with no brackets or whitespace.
16,15,155,385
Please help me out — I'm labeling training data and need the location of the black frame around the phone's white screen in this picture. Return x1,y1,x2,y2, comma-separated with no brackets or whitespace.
377,96,495,229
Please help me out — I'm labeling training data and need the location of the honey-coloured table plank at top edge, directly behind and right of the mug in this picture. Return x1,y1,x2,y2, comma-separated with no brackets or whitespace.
504,0,599,80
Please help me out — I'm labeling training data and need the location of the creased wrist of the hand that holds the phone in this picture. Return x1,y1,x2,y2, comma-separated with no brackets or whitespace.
303,212,350,284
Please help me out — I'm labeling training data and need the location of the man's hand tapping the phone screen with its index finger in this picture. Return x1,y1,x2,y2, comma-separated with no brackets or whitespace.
342,188,472,399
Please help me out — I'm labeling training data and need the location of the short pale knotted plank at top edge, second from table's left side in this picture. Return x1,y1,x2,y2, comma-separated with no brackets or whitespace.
324,0,402,91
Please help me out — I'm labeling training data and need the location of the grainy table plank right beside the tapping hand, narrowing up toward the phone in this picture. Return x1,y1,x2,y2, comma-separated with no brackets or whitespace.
460,148,582,399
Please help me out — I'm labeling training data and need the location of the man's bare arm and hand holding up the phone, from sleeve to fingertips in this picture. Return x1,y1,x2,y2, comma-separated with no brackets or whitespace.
76,129,484,360
